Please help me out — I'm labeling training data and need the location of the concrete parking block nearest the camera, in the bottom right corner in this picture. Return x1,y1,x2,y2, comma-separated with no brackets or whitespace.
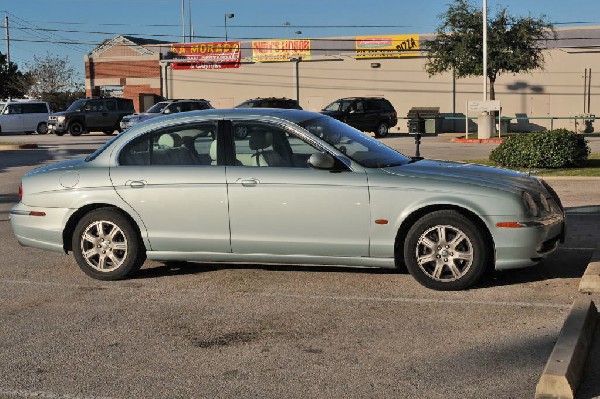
535,299,598,399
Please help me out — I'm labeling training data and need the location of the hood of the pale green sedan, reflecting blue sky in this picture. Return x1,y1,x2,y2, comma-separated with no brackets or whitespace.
384,160,541,192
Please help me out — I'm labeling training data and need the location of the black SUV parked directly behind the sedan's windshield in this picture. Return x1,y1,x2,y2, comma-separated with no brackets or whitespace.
321,97,398,137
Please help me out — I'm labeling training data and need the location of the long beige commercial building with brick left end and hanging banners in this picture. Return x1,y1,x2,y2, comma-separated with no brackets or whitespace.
85,27,600,131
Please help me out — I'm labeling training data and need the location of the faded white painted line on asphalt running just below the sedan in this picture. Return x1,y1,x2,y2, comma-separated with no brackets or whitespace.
0,279,571,309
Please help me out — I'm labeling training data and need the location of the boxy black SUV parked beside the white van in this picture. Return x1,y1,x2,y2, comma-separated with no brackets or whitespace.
48,97,135,136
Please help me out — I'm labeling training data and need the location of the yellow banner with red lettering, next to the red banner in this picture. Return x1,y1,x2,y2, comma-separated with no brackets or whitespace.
252,39,310,62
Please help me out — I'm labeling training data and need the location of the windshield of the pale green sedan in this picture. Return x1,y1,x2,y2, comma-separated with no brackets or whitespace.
299,116,410,168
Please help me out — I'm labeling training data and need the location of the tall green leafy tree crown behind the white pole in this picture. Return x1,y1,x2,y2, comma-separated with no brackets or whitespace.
424,0,556,100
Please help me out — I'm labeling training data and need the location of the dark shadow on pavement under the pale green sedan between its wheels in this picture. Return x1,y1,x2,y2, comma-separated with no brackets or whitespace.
133,262,399,279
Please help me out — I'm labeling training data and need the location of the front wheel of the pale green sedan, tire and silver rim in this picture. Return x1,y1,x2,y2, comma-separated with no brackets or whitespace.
404,210,490,291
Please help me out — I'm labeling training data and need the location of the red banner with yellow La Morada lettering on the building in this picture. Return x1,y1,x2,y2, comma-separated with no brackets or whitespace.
171,42,242,69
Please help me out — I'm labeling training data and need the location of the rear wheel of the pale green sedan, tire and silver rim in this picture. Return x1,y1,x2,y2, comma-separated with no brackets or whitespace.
72,208,146,280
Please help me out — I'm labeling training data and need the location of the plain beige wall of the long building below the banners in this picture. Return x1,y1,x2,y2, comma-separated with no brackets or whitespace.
163,49,600,131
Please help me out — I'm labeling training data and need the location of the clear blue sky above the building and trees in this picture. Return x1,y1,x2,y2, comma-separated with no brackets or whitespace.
0,0,600,81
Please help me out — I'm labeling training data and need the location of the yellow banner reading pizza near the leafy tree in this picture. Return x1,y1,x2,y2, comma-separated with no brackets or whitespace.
356,34,419,58
